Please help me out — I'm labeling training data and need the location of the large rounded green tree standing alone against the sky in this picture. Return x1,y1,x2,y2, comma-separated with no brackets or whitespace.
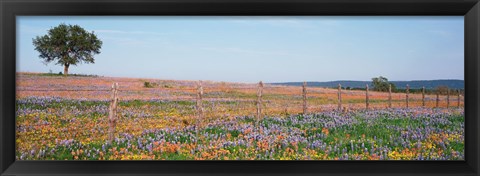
33,23,102,76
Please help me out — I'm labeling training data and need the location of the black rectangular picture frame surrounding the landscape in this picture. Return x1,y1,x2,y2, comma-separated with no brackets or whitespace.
0,0,480,176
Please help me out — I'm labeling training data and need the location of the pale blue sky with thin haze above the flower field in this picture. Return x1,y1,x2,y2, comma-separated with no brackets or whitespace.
17,16,464,82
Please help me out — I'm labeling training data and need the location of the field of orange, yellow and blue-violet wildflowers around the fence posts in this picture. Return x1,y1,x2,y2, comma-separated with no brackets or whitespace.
16,73,465,160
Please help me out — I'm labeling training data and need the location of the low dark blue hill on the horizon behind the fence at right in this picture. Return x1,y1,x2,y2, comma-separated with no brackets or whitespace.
268,79,465,89
